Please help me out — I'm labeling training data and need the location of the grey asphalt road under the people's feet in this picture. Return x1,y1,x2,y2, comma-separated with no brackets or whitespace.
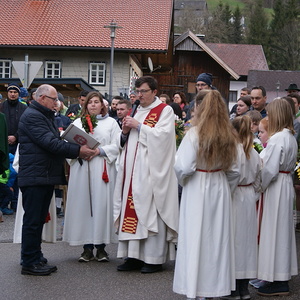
0,216,300,300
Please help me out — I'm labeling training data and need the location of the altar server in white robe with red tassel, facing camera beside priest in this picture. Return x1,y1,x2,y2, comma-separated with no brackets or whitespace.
63,91,120,262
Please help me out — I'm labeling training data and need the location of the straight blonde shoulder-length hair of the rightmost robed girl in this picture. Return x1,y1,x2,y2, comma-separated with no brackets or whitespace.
267,98,295,136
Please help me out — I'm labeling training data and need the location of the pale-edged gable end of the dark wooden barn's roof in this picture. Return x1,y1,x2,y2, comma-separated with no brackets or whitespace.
174,30,240,80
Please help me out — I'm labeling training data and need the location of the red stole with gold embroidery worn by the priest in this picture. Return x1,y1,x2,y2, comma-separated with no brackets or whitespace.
122,103,167,234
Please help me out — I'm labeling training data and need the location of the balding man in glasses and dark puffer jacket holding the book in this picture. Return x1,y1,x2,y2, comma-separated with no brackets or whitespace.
19,84,96,275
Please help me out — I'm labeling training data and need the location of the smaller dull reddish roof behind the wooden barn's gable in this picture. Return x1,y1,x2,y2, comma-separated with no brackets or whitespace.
205,43,269,76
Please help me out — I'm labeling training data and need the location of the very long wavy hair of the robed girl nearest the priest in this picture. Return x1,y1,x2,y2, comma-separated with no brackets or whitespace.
193,90,237,171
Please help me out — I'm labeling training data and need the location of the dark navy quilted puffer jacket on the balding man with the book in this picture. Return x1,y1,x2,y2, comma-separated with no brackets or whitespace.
18,101,80,187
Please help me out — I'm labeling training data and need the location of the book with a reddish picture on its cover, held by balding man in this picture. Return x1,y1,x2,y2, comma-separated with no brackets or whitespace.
61,124,100,149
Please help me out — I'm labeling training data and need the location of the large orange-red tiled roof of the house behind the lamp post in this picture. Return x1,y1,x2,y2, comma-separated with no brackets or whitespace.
0,0,173,52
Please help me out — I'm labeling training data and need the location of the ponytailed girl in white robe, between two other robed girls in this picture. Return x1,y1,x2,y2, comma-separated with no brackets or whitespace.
222,115,261,300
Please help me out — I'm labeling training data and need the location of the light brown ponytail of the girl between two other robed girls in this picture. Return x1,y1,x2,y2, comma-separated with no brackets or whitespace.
232,115,253,159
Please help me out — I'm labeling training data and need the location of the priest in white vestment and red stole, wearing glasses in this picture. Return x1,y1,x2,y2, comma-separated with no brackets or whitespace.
114,76,178,273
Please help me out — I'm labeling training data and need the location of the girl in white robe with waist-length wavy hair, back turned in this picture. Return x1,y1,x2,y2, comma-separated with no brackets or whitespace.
173,90,242,299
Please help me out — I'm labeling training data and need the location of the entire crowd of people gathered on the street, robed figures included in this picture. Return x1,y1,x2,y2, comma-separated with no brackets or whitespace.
0,73,300,300
